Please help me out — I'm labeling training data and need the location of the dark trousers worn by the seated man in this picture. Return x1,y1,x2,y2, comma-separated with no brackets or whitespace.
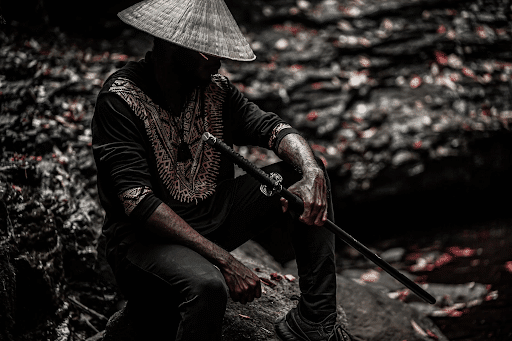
115,162,336,341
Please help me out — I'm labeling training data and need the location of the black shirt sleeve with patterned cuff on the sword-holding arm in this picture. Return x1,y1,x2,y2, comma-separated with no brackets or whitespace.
227,82,300,152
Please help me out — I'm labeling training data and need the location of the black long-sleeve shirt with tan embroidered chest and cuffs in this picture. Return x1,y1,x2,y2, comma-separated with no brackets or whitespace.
92,52,298,252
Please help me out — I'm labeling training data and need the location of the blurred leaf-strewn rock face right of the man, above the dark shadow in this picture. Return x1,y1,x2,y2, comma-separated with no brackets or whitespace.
226,1,512,205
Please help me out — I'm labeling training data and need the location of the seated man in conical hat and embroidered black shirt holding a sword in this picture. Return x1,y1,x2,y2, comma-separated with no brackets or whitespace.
92,0,352,341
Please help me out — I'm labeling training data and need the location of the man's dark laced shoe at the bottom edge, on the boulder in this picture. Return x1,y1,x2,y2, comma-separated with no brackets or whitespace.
274,307,352,341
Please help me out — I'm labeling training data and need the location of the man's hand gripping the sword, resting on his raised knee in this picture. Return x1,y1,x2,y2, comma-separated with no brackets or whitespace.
281,168,327,226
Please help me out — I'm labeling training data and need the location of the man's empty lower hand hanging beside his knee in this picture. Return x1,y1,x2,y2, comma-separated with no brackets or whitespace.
220,257,261,304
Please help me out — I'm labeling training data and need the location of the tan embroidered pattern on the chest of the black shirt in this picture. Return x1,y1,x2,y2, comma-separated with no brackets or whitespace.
109,75,228,203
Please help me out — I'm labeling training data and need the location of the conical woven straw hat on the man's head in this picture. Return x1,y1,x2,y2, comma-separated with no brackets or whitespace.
118,0,256,61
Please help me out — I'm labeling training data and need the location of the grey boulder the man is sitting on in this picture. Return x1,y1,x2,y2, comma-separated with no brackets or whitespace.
94,242,448,341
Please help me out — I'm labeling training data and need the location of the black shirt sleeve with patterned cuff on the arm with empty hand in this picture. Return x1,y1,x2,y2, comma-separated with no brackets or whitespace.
91,93,162,222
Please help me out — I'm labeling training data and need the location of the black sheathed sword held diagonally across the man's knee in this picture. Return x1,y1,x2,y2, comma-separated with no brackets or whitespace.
202,132,436,304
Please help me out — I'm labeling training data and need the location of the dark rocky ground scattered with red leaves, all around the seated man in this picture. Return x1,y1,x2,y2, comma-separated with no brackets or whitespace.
0,0,512,341
